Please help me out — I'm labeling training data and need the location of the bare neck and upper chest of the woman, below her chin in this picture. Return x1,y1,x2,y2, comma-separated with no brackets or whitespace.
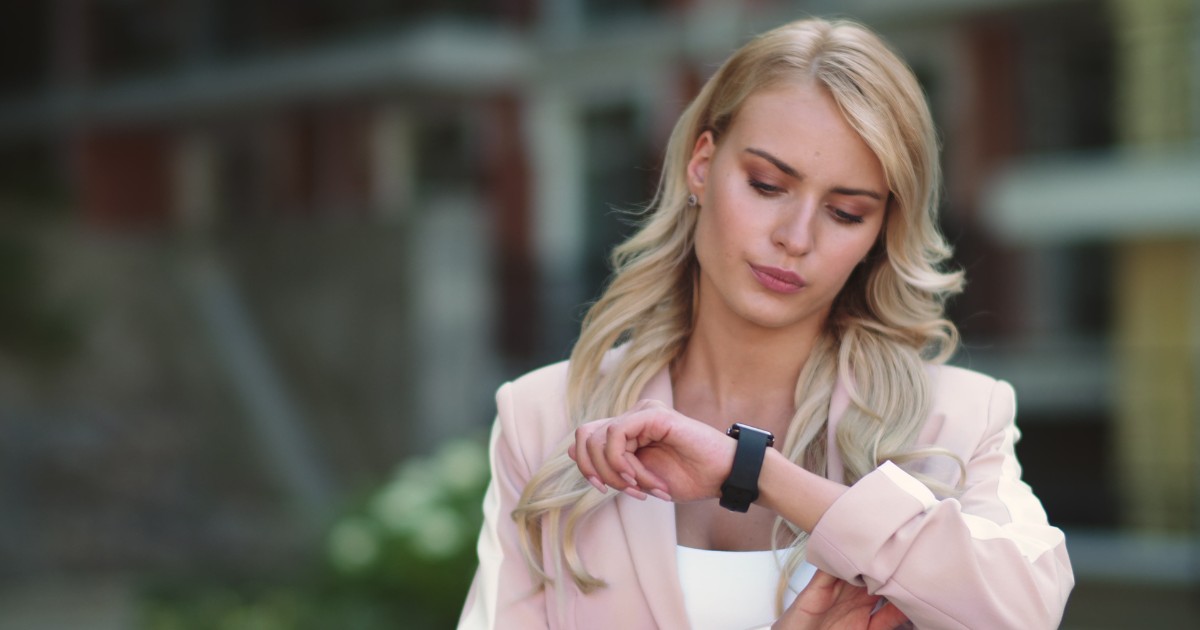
672,304,821,434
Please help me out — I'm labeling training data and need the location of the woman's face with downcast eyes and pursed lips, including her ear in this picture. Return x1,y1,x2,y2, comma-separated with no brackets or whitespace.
688,85,888,330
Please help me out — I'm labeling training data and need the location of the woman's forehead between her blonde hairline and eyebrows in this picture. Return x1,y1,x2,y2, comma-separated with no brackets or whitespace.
722,83,887,191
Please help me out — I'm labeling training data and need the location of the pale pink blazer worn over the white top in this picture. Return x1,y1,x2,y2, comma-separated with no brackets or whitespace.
458,362,1074,630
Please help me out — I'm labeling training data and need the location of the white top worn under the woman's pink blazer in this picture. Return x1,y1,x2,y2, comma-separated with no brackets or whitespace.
676,546,817,630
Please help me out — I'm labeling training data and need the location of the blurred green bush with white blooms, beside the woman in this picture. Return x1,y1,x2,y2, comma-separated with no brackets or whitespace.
143,439,488,630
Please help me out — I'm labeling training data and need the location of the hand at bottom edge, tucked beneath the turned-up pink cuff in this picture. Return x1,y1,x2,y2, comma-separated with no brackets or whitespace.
772,570,911,630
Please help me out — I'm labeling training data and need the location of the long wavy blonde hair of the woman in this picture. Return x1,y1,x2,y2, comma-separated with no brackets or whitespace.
512,19,962,610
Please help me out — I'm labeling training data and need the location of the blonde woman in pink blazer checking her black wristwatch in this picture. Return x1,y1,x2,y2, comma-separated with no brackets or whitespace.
461,19,1073,630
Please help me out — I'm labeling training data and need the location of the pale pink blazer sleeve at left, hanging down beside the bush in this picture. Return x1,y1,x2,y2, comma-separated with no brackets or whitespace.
458,383,548,630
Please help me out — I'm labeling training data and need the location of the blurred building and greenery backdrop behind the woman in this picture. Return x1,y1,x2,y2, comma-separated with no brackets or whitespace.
0,0,1200,630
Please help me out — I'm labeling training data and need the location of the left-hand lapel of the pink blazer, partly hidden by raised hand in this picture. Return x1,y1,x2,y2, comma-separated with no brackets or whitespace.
616,367,689,628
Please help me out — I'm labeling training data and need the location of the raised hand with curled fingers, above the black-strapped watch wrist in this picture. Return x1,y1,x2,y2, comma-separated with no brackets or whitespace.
566,401,737,502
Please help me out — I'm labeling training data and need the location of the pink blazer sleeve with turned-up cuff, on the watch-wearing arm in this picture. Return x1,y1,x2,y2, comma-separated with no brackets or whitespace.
808,382,1074,630
